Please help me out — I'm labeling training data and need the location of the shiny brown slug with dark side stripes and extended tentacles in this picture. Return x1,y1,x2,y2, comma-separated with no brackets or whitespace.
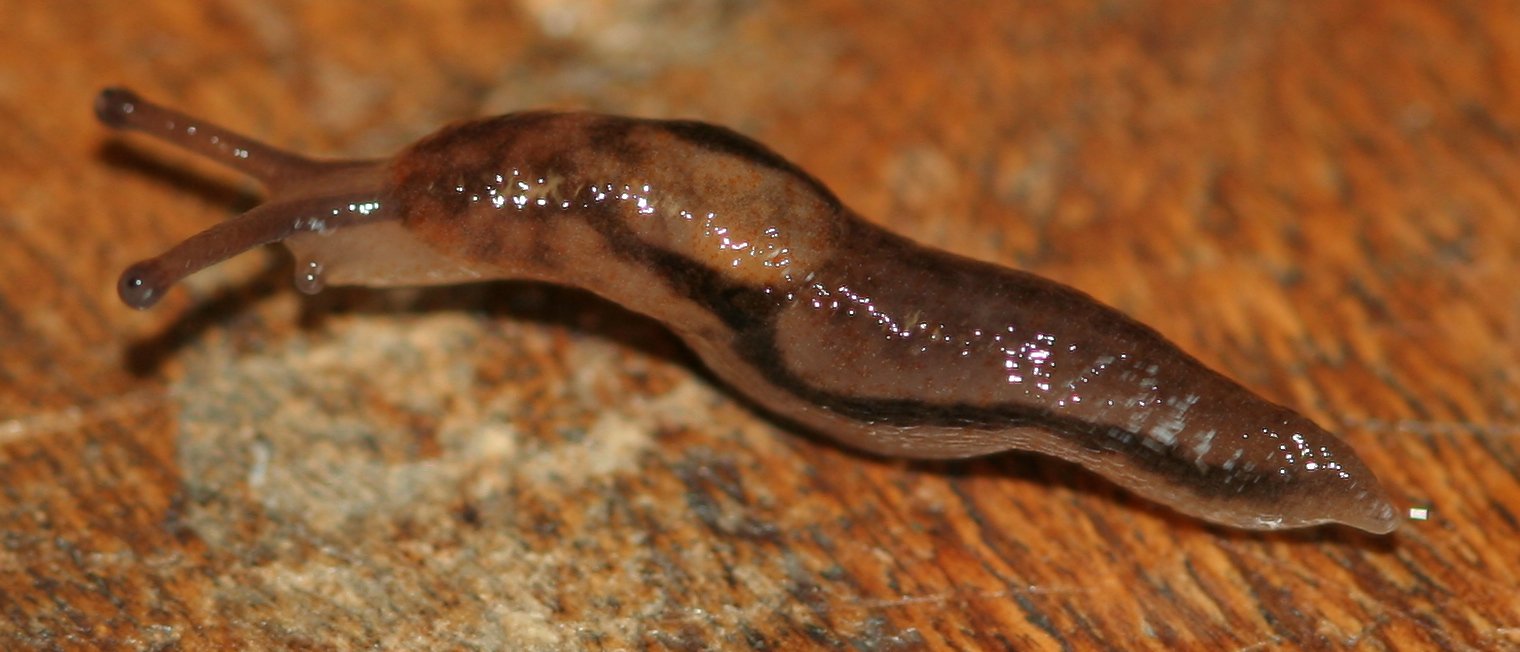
94,88,1398,533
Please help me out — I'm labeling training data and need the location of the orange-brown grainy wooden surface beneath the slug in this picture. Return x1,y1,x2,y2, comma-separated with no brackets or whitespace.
0,0,1520,649
